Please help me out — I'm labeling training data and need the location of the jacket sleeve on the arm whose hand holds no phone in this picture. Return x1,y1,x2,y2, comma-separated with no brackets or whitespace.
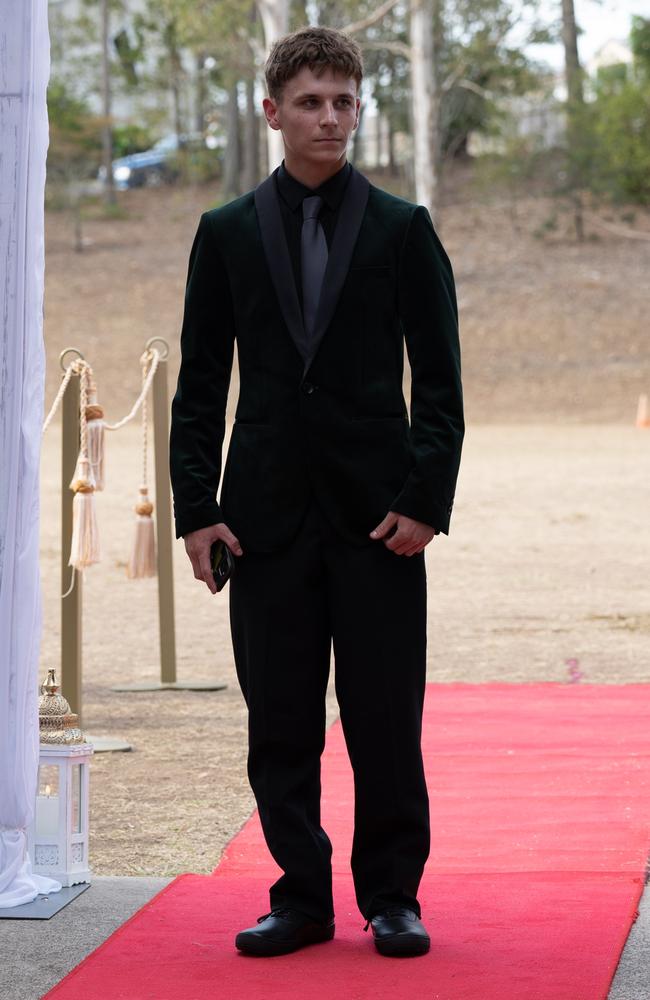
390,205,465,535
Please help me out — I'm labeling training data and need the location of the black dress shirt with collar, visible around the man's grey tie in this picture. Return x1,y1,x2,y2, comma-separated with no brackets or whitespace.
275,160,351,309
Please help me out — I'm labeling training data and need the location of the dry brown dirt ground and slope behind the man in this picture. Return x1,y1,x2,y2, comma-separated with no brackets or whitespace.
40,170,650,875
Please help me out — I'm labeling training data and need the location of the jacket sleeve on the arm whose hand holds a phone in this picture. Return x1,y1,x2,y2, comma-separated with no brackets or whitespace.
169,212,235,538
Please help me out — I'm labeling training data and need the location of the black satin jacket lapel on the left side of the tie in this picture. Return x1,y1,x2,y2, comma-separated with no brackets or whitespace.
255,170,308,360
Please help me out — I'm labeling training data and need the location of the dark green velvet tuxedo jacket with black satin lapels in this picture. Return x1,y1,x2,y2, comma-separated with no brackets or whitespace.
170,168,464,552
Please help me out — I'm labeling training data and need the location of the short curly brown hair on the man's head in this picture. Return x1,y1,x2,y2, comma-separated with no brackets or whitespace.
264,26,363,103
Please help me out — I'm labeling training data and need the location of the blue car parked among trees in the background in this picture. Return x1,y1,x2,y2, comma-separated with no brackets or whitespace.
97,132,223,191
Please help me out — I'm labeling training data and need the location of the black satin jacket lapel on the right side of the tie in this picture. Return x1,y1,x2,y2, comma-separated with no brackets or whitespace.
305,167,370,372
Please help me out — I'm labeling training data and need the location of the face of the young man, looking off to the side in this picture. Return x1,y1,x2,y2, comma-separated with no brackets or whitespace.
264,66,361,166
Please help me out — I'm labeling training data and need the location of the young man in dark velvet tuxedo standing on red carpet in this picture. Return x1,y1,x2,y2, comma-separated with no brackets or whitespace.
170,28,464,955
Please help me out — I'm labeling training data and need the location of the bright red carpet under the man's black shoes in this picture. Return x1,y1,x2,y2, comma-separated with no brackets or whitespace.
46,683,650,1000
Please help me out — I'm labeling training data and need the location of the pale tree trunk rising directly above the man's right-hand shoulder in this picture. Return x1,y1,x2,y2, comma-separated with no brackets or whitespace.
411,0,438,222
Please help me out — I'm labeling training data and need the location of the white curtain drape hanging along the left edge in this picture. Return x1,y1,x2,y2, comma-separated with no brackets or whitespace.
0,0,61,909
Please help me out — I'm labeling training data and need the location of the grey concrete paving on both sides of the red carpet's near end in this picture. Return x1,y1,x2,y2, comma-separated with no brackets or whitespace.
0,876,650,1000
